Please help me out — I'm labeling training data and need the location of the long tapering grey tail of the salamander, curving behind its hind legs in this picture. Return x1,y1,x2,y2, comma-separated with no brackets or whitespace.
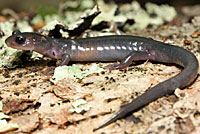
94,46,199,131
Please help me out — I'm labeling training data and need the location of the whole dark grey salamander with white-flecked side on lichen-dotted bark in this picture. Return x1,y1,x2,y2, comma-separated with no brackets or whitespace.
5,30,199,131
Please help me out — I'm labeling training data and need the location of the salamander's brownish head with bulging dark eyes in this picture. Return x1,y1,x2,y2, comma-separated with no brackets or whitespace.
5,30,46,50
